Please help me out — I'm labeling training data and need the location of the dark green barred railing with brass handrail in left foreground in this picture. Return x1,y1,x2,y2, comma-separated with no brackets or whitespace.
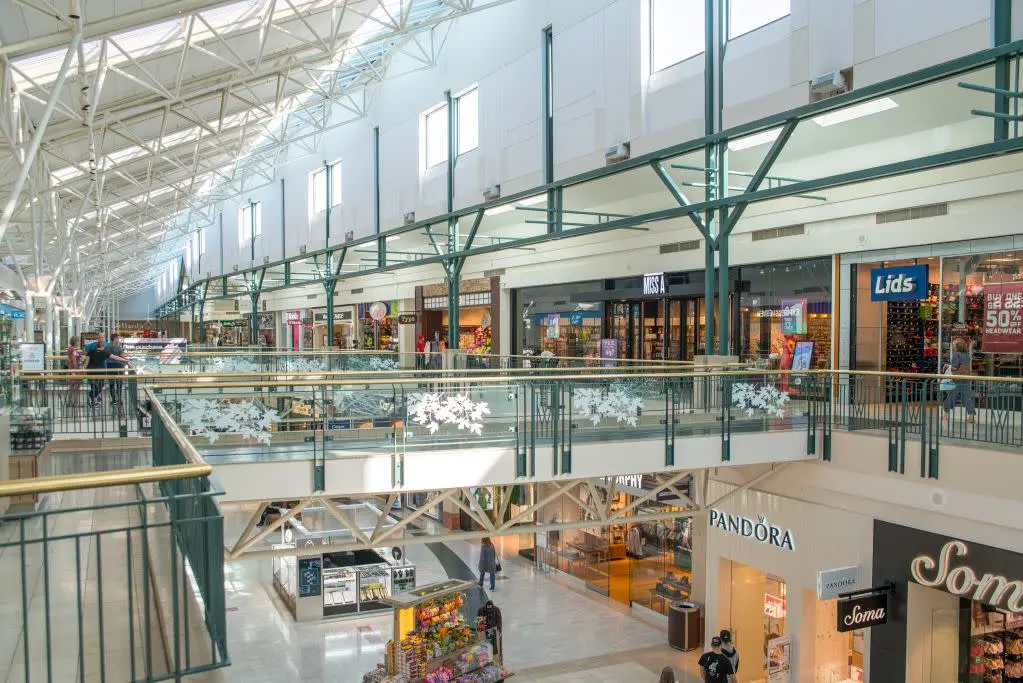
0,394,229,682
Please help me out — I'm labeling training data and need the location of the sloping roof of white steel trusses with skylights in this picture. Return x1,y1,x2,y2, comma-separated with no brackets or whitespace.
0,0,513,309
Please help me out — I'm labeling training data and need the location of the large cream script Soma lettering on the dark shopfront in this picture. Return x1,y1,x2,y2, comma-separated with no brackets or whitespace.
909,541,1023,613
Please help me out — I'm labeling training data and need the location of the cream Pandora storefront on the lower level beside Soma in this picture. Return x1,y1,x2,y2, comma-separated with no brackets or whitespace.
694,482,875,683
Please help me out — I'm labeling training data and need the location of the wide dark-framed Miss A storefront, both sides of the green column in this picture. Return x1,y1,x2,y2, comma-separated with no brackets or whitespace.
513,258,832,369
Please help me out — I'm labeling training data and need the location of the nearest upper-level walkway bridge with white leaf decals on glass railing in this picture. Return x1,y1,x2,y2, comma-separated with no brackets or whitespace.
19,352,1023,500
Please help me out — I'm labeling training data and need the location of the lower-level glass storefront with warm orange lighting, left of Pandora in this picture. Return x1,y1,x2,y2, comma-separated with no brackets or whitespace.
536,475,693,614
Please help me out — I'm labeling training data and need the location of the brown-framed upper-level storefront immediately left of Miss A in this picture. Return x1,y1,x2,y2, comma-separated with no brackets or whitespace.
415,277,500,355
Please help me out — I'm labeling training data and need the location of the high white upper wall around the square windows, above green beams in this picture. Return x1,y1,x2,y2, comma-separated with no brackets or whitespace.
178,0,998,290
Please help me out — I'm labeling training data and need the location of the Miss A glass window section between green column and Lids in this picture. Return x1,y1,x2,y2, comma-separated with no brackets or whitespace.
739,259,832,370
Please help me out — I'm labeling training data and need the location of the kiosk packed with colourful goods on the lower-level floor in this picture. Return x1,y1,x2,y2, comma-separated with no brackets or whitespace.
362,580,512,683
